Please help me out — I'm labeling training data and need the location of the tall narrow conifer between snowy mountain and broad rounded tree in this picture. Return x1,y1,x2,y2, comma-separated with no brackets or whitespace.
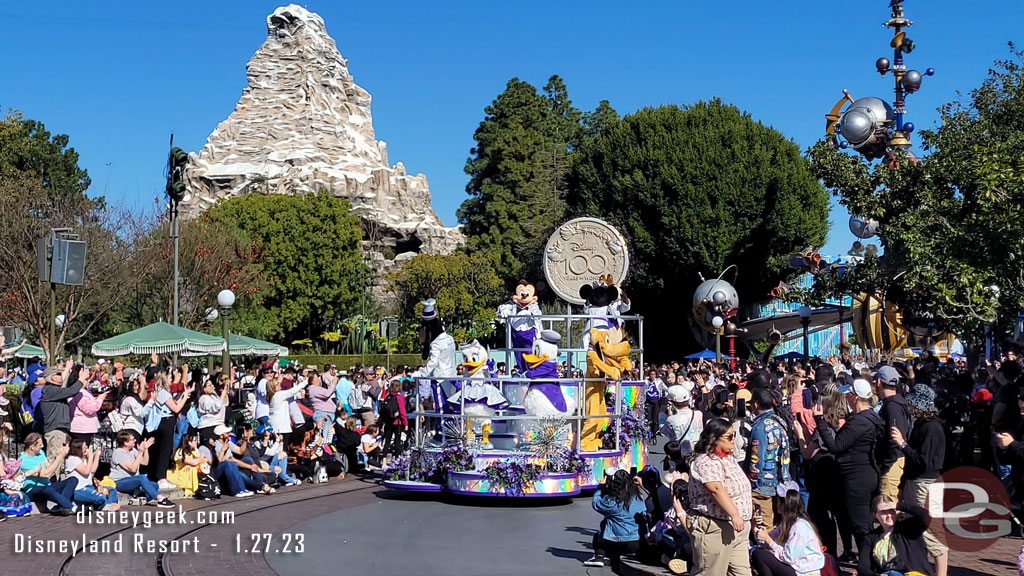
458,76,580,282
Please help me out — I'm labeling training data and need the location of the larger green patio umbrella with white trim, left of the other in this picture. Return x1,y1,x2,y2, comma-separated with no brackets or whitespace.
92,322,224,356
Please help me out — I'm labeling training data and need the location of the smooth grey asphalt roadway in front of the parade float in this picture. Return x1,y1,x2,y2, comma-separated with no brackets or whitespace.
266,485,600,576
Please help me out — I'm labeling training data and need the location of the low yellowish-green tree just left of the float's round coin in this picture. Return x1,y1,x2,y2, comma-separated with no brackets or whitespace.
388,252,504,342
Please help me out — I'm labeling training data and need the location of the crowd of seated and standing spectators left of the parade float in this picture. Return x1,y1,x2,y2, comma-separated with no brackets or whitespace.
0,355,416,521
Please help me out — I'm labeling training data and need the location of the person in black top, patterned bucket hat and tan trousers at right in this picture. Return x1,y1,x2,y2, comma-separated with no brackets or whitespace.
889,384,949,576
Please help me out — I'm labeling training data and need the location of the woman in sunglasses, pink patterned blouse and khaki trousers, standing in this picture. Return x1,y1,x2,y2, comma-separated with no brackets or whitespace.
686,418,754,576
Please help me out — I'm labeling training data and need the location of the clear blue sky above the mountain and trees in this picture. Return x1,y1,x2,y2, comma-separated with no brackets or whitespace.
0,0,1024,254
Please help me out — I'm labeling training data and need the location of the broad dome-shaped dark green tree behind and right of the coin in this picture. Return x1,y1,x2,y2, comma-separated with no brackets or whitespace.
566,100,828,355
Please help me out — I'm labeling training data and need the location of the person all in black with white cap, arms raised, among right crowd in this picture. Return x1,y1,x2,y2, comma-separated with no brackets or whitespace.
814,379,888,560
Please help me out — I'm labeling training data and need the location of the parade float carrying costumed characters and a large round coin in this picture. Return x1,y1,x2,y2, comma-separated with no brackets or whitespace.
383,218,650,498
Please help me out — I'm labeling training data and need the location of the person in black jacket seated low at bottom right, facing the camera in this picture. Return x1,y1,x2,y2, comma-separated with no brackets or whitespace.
857,494,935,576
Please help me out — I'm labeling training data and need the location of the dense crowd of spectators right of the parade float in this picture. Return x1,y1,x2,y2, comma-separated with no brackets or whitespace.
585,352,1024,576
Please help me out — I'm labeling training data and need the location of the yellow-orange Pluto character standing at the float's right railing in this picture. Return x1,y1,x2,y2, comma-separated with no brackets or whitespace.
580,326,633,452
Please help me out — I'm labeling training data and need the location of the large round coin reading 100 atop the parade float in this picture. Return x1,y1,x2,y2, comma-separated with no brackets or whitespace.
544,217,630,304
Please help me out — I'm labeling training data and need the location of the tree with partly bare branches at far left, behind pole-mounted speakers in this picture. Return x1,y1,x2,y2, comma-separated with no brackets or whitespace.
0,113,151,354
